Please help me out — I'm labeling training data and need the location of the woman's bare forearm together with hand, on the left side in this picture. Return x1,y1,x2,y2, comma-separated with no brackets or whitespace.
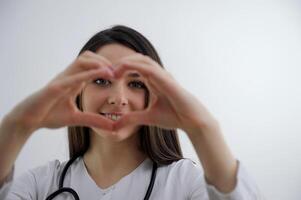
0,51,116,187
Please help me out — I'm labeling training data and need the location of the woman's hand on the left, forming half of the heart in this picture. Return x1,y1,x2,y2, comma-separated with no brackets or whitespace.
6,51,114,132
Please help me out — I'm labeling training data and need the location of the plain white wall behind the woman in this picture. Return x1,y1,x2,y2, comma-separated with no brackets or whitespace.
0,0,301,200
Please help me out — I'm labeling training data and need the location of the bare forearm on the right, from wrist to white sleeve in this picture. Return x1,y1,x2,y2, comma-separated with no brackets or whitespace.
185,120,238,193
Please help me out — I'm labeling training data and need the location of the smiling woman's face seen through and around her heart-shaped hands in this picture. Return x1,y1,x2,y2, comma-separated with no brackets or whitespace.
82,44,146,141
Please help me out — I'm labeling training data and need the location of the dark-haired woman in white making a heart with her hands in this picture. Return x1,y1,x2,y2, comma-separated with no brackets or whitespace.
0,26,261,200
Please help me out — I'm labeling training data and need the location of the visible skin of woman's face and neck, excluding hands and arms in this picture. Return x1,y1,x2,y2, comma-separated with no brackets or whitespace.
82,44,146,188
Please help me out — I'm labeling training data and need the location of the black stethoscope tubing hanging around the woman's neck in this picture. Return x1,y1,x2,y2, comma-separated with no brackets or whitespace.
46,156,158,200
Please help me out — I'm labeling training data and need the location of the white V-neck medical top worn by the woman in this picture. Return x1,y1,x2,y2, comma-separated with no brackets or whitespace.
0,157,263,200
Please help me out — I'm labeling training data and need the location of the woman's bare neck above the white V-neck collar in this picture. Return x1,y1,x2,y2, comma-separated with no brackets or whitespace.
83,131,147,185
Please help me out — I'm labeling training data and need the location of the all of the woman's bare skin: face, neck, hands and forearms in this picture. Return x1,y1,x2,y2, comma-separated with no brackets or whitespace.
0,44,238,192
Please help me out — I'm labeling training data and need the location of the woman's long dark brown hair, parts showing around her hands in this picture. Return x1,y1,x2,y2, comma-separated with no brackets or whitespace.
68,25,183,165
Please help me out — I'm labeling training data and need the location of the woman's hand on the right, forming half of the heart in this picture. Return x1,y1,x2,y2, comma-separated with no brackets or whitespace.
110,53,215,131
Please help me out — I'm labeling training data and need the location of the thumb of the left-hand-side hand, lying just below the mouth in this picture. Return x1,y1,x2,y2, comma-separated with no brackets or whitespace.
70,111,113,130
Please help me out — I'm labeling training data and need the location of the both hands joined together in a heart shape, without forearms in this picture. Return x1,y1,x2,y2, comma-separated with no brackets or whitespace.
7,51,213,137
